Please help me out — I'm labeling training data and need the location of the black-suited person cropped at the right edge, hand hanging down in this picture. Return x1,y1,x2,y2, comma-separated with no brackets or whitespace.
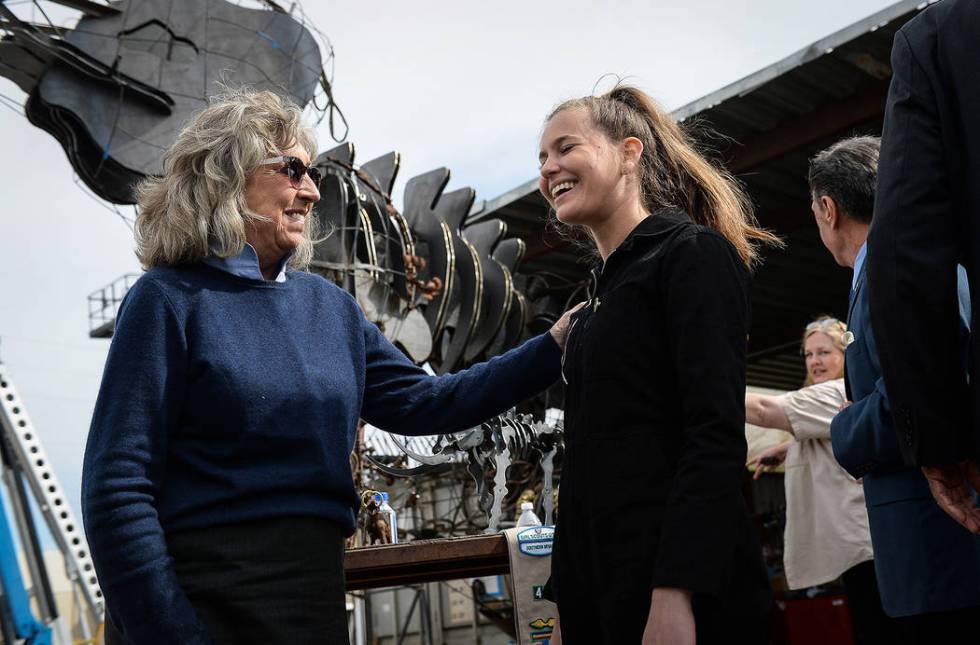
868,0,980,533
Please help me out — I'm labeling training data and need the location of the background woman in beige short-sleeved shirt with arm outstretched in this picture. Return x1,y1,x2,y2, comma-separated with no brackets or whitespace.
745,316,900,645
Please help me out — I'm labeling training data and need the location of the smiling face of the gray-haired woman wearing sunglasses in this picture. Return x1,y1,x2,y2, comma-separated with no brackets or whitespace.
245,144,320,267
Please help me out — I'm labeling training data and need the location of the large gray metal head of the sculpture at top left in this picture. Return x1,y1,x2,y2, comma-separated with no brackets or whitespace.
0,0,326,204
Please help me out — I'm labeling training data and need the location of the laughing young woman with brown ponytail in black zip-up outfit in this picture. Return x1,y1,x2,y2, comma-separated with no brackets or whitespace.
539,86,778,645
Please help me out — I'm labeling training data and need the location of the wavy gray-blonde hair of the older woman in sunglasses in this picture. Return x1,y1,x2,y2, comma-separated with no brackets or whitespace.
135,88,317,269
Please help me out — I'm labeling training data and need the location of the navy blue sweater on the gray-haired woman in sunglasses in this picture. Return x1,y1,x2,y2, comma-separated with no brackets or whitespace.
82,264,561,645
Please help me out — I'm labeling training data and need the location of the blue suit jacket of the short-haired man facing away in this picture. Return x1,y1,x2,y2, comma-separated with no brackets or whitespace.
830,256,980,616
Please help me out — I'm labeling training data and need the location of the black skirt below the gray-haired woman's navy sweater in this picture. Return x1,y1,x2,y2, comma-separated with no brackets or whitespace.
106,517,350,645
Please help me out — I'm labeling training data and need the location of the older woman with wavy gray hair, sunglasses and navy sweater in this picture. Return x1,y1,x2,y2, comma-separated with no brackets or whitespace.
82,90,568,645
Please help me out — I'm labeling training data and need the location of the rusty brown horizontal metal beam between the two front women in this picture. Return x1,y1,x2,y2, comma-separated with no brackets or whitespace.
344,533,510,591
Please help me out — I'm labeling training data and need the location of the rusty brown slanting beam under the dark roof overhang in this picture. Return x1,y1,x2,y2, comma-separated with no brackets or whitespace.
725,80,889,174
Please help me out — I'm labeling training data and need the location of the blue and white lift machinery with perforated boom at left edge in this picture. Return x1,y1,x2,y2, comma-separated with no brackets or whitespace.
0,363,104,645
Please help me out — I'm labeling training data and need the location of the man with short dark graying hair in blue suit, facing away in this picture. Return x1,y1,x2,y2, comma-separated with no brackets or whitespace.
809,137,980,643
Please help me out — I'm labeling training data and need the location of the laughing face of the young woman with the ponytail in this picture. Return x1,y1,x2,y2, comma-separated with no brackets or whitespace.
538,108,642,229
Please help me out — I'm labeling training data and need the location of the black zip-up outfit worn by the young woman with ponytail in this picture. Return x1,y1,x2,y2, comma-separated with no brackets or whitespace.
552,210,769,644
